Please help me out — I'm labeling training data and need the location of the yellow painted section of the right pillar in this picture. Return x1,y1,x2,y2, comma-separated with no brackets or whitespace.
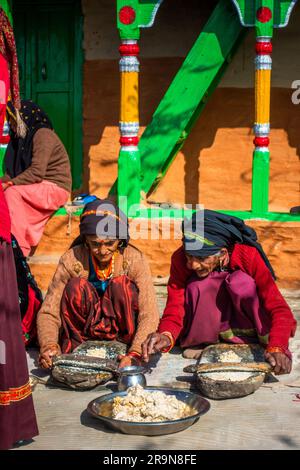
255,70,271,124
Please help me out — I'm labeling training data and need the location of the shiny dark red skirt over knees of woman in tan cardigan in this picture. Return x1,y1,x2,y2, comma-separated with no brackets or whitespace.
60,276,138,353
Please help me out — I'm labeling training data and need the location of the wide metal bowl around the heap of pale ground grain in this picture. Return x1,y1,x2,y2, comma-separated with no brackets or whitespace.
87,387,210,436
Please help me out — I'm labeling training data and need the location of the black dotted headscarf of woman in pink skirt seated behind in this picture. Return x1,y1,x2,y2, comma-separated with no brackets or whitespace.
4,100,53,178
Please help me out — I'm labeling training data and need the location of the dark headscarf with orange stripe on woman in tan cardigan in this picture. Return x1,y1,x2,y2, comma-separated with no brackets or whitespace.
77,199,129,247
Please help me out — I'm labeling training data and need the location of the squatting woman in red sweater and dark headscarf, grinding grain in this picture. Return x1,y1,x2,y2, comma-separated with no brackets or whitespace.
143,210,296,374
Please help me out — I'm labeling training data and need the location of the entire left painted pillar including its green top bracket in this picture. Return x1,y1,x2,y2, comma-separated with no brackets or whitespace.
117,0,162,210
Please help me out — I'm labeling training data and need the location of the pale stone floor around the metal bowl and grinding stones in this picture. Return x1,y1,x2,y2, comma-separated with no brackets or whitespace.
21,286,300,451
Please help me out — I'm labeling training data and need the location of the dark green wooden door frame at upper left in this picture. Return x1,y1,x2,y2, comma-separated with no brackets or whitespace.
10,0,84,189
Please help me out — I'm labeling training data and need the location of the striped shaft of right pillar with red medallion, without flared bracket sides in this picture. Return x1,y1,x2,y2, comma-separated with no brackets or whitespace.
252,0,273,214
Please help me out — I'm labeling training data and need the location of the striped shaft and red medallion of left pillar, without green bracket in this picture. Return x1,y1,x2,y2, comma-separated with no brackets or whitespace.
117,5,141,210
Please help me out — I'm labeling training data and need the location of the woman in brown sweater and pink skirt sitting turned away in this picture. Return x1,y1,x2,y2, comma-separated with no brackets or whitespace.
1,101,71,256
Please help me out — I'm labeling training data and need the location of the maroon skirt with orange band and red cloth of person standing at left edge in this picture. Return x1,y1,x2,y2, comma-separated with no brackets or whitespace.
0,183,38,450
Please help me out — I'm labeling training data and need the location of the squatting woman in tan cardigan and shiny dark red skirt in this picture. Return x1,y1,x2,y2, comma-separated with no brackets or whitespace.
37,199,159,368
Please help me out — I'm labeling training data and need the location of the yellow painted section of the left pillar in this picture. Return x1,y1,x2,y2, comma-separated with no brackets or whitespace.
120,72,139,122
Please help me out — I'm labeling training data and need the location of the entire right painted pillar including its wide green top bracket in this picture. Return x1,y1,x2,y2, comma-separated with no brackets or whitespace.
232,0,296,216
